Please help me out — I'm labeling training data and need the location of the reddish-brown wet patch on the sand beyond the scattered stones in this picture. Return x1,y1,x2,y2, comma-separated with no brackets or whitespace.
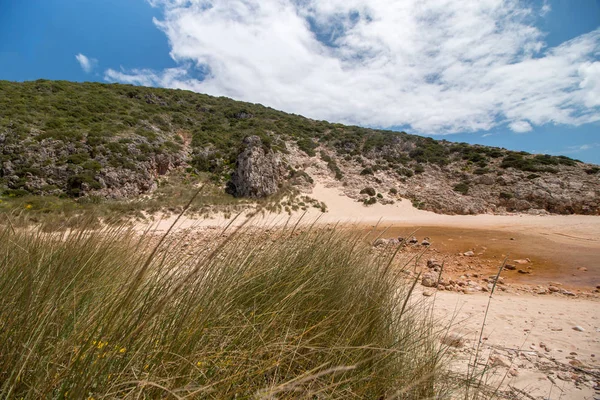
365,226,600,290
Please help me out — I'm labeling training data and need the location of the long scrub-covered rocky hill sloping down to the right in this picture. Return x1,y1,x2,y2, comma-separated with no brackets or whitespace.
0,80,600,215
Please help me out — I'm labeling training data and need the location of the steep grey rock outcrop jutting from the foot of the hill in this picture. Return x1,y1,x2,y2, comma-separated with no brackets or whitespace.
229,136,281,198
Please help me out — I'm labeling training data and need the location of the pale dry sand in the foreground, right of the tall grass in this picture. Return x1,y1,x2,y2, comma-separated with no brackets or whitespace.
434,292,600,399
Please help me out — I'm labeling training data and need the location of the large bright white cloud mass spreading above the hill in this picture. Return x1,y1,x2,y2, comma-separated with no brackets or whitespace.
105,0,600,133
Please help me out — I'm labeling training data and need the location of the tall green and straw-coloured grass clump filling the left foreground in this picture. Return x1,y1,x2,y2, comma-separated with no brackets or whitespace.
0,220,447,399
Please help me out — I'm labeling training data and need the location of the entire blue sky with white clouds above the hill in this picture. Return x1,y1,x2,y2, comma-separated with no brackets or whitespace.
0,0,600,164
